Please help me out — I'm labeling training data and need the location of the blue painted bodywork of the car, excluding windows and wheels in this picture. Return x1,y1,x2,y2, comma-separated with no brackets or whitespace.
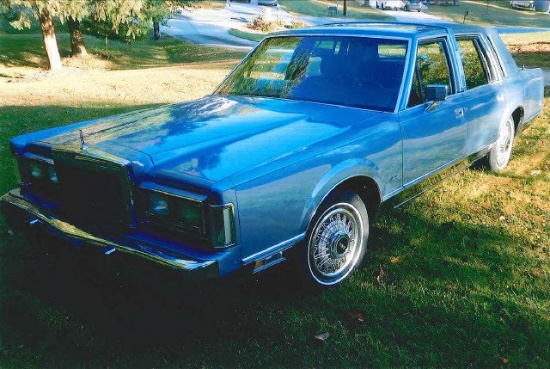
2,23,543,276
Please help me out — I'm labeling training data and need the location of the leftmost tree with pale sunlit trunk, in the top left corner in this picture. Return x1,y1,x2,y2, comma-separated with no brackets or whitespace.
0,0,63,70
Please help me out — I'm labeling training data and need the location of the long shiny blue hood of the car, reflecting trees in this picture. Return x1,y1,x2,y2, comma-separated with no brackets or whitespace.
42,95,383,181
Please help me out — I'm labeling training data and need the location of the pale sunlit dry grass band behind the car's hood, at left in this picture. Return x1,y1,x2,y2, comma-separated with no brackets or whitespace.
0,64,230,107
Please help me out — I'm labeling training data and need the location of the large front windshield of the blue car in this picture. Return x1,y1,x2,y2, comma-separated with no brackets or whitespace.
216,36,408,111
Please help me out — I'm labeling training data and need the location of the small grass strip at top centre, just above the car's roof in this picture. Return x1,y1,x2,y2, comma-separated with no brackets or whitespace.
279,0,393,20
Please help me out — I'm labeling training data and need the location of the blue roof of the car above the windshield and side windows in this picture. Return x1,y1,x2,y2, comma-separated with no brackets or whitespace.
272,21,483,38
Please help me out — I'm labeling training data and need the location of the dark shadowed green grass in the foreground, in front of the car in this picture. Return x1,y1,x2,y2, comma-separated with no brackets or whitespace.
0,200,550,367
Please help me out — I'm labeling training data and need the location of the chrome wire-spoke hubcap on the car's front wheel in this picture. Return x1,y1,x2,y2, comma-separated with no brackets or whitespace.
309,204,363,284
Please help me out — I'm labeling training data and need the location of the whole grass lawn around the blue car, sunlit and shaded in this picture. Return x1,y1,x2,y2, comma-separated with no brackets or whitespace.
0,25,550,368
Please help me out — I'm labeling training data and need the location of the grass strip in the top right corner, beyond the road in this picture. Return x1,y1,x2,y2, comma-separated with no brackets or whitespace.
426,0,550,28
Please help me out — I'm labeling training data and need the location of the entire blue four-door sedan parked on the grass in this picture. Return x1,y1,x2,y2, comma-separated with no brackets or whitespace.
1,23,543,286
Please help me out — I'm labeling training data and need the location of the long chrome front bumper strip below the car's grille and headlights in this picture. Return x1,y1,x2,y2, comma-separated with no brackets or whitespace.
0,190,217,271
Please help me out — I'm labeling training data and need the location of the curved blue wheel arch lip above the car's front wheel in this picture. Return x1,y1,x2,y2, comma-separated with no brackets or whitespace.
300,159,381,232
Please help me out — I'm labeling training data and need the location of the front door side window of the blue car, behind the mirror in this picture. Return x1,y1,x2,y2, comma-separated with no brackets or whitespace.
408,41,452,107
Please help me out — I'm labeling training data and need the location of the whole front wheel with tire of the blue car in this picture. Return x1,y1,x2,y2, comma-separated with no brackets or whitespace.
307,192,369,286
